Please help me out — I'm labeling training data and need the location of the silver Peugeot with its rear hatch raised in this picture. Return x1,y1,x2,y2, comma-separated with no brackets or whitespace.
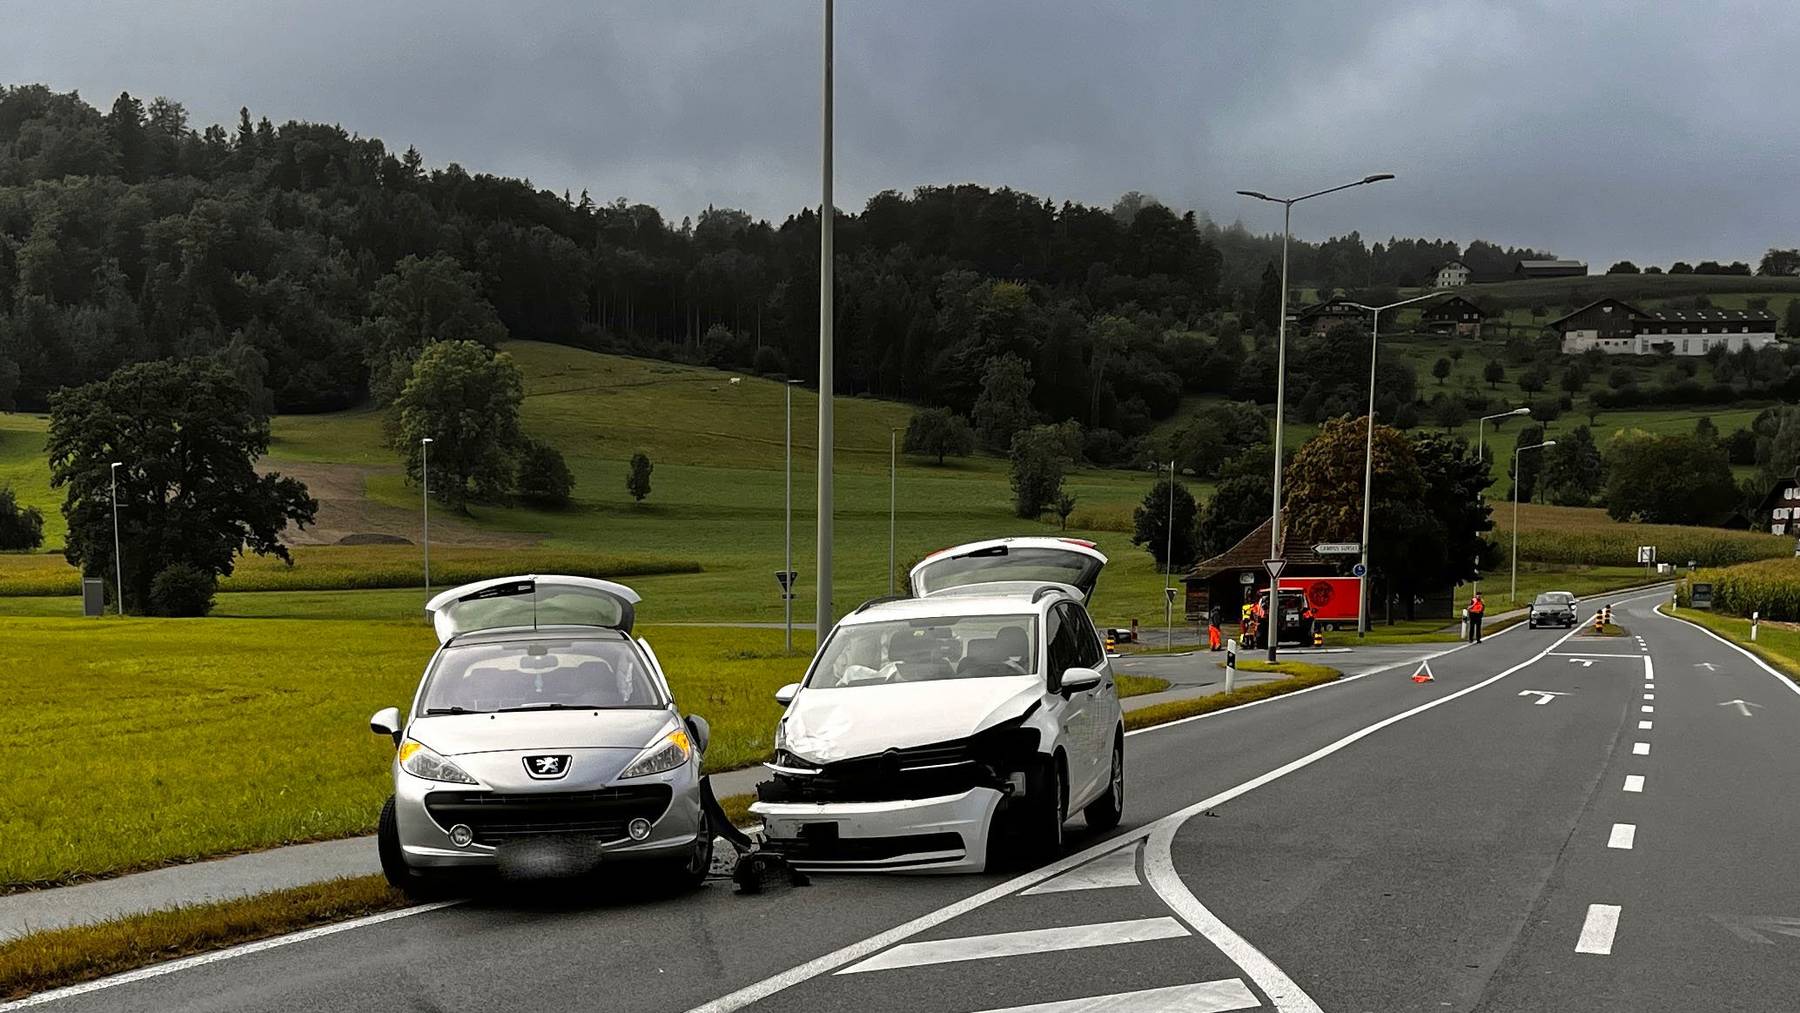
369,576,713,894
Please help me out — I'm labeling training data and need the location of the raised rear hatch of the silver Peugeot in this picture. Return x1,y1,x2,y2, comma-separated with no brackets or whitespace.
425,574,639,644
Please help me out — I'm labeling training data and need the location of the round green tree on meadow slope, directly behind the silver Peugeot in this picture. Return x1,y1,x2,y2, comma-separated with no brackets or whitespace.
387,342,524,513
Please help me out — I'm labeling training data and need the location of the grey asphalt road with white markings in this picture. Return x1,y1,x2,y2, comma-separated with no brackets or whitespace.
17,592,1800,1013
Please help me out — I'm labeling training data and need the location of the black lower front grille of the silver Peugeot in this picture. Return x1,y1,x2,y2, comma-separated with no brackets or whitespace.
425,784,673,846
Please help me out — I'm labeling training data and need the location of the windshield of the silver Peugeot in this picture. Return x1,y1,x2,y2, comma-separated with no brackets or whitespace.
419,639,664,714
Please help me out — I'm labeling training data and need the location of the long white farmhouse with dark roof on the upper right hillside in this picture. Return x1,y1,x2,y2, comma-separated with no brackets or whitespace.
1548,297,1775,354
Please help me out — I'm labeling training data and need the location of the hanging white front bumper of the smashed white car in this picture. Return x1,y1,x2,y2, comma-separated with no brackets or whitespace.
751,788,1004,873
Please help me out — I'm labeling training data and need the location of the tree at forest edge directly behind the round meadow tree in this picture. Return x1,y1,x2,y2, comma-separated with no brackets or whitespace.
360,254,506,403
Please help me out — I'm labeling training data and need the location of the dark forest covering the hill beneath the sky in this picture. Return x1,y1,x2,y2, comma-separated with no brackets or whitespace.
0,85,1532,437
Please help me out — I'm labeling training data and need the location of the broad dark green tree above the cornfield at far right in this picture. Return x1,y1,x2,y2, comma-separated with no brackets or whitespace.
1600,430,1737,524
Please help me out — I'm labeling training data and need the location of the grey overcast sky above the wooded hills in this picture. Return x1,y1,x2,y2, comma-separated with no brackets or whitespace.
0,0,1800,270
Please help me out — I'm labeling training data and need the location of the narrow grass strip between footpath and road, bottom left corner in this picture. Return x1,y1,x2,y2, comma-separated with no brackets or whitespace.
0,876,407,1000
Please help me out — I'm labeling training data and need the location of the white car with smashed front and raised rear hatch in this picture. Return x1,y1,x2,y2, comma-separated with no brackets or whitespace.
751,538,1125,873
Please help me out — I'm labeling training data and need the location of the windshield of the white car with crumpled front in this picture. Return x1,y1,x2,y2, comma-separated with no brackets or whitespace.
806,615,1037,689
